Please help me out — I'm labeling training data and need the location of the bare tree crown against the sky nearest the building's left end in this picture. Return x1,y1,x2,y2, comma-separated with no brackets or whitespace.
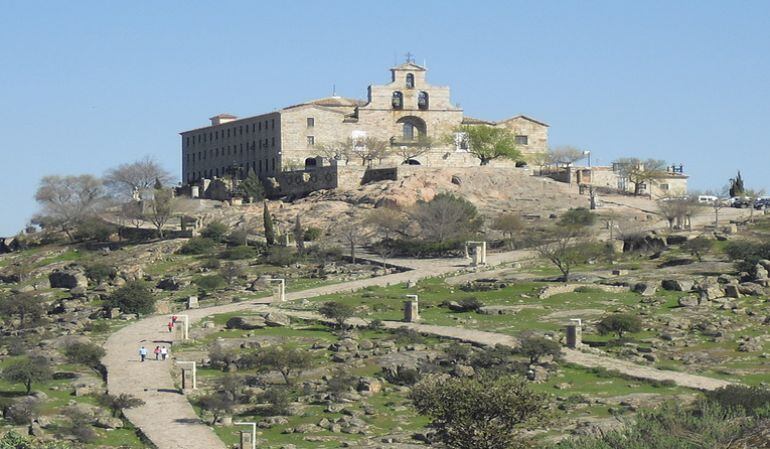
104,156,174,199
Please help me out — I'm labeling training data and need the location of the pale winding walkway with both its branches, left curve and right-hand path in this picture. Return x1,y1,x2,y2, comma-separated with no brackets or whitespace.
103,251,727,449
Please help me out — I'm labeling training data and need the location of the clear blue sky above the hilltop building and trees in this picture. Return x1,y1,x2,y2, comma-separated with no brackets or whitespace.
0,0,770,235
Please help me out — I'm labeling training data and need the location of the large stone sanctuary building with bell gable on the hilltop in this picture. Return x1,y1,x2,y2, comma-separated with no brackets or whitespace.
181,59,548,184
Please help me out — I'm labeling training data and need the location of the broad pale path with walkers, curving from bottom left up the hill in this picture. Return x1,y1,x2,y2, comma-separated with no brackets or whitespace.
103,251,531,449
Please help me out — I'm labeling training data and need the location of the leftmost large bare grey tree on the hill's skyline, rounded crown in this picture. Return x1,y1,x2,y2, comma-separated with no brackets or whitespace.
35,175,105,239
